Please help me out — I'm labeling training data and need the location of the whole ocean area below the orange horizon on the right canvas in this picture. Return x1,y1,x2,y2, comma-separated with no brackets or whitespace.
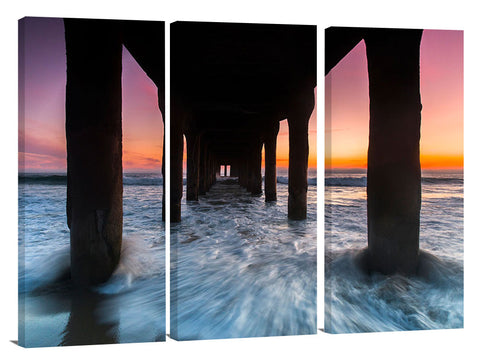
325,170,464,333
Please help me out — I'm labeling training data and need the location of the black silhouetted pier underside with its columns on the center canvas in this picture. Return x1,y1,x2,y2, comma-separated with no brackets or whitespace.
170,22,316,222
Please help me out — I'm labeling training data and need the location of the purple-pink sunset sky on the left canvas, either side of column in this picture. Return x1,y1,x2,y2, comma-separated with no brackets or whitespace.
19,18,163,172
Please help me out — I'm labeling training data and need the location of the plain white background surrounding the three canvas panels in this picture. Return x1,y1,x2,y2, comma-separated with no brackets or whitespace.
0,0,480,360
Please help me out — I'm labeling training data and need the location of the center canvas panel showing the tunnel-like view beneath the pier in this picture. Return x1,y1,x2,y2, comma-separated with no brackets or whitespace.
170,22,317,340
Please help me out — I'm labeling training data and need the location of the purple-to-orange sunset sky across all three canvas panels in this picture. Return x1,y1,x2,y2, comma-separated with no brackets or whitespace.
19,18,463,172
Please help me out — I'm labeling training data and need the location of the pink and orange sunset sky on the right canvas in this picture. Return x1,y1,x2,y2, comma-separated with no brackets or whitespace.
325,30,463,169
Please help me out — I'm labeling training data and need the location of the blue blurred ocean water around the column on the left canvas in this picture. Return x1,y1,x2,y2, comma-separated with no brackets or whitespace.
18,173,165,347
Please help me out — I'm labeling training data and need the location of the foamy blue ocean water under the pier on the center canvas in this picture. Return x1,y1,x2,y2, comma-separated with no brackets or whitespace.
170,168,317,340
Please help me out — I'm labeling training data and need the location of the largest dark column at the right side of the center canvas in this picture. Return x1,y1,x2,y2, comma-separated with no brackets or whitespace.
287,89,315,220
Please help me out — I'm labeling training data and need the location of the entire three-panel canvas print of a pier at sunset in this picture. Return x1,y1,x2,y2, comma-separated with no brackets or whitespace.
18,17,463,347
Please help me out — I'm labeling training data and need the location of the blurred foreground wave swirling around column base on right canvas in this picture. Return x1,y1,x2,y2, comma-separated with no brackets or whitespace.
325,249,463,333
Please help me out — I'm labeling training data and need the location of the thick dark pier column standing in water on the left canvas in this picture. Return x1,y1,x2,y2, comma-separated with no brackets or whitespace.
64,19,123,286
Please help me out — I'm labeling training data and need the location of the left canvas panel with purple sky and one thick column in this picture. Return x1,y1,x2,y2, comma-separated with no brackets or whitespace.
18,17,165,347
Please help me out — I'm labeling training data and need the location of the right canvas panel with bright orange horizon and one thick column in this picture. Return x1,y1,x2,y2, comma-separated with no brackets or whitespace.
325,27,464,333
